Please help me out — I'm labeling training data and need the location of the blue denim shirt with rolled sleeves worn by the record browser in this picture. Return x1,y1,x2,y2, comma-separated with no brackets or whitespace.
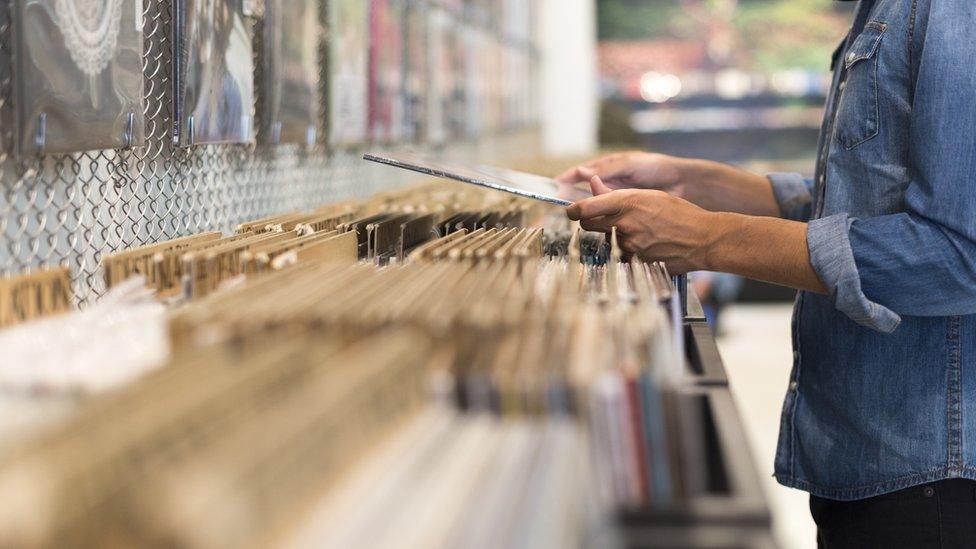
770,0,976,500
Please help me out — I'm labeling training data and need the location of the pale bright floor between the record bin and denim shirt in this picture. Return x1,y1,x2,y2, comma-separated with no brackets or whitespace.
718,304,816,549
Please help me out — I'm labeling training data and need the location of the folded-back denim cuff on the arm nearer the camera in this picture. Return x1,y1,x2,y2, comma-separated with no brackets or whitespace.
807,214,901,333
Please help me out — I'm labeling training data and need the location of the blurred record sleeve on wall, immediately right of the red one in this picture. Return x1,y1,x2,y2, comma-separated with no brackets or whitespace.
402,0,430,142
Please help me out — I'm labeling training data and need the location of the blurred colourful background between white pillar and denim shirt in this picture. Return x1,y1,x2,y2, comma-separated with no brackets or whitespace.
597,0,854,161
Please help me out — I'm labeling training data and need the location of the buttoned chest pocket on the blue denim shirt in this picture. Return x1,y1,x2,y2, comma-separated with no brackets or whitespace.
834,21,888,150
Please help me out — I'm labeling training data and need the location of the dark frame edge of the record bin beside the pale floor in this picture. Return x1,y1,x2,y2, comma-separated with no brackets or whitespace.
618,291,776,549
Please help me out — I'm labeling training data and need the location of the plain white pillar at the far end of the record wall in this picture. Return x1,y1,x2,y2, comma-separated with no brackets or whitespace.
538,0,599,156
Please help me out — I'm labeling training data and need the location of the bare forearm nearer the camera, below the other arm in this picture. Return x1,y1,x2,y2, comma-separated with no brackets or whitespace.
701,213,826,294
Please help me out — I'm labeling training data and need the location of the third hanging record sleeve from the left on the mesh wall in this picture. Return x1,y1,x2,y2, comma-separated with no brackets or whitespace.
259,0,319,147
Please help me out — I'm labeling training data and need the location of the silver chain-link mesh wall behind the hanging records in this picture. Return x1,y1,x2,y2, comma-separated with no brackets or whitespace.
0,0,538,305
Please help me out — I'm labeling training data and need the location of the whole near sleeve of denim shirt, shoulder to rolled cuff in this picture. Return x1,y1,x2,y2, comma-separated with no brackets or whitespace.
807,0,976,332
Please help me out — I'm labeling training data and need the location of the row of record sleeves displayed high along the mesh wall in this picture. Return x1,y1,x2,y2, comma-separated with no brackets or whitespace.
5,0,538,156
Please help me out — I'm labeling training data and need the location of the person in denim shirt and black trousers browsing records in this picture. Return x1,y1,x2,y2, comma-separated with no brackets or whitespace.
560,0,976,548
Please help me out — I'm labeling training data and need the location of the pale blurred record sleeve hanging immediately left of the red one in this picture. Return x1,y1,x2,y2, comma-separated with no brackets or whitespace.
329,0,369,147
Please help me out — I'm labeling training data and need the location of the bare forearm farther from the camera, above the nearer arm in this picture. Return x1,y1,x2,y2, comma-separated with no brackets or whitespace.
676,159,780,217
